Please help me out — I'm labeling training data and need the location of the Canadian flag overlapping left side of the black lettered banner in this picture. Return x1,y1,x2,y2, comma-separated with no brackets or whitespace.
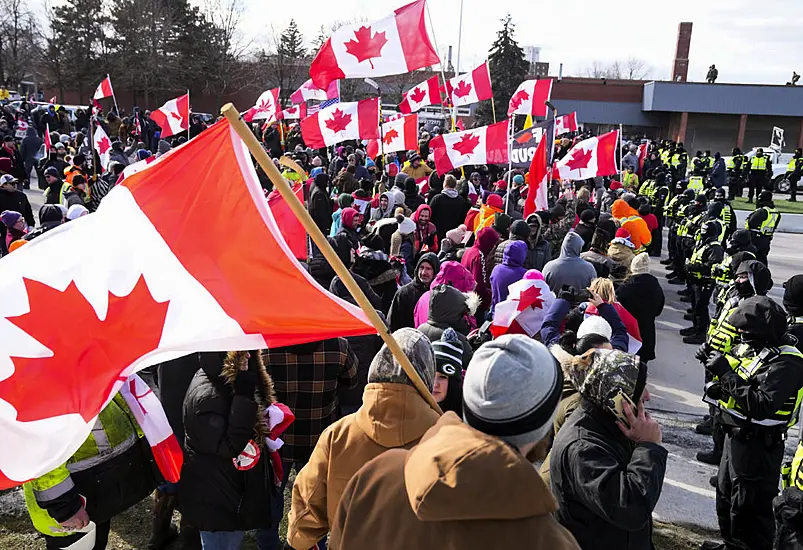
429,120,509,175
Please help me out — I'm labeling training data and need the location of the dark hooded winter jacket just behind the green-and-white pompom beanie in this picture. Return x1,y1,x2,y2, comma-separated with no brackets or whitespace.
418,285,476,365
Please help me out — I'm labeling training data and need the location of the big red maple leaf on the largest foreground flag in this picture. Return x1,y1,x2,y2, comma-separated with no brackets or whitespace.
0,277,168,422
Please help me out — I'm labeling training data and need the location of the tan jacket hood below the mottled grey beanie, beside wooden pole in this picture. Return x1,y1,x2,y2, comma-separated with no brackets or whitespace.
355,382,439,449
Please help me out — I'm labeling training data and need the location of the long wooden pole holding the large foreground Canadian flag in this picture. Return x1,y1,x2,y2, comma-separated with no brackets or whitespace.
220,103,443,413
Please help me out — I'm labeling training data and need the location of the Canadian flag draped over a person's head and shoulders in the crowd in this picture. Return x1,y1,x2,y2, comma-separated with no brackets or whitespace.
491,278,555,338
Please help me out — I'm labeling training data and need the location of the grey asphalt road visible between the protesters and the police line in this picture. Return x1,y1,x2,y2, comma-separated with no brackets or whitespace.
648,229,803,531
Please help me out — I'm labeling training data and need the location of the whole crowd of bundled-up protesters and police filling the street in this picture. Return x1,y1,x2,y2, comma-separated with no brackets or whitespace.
0,98,803,550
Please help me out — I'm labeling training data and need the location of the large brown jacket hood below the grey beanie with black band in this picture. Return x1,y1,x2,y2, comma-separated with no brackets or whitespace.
404,412,557,521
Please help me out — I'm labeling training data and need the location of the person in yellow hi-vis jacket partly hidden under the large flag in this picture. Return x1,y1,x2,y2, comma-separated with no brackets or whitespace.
23,394,156,550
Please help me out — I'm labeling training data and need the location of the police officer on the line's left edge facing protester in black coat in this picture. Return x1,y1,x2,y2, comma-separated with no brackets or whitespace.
680,220,725,345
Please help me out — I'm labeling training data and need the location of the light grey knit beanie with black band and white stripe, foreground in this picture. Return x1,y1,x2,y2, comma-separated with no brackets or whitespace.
463,334,563,449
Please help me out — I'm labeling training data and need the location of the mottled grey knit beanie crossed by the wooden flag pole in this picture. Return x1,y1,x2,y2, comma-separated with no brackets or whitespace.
368,328,435,391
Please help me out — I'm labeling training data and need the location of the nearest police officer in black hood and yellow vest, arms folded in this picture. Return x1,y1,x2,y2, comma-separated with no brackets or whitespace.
703,296,803,550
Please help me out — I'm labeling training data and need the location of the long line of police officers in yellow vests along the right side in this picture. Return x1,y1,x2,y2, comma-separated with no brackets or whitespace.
639,143,803,550
